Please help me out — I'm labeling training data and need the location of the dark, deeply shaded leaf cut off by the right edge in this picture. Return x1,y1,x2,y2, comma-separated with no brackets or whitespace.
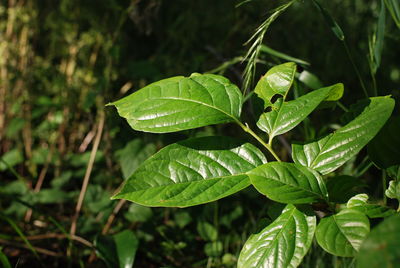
367,116,400,169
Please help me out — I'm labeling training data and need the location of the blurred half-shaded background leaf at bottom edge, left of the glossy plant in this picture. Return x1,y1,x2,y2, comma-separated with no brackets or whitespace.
94,230,139,268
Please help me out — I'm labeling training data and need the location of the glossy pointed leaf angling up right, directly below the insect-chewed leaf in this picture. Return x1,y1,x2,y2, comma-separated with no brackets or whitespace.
257,84,343,139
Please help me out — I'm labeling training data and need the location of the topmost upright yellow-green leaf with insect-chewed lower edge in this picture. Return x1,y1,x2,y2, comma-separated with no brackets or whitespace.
254,62,296,108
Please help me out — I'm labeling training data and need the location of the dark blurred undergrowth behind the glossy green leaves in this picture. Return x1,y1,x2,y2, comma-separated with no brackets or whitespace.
0,0,400,267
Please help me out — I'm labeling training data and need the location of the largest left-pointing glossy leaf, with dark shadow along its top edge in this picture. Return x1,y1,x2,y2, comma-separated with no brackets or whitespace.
113,137,266,207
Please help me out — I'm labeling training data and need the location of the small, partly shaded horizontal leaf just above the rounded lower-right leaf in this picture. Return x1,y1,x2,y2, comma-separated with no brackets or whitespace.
347,194,396,219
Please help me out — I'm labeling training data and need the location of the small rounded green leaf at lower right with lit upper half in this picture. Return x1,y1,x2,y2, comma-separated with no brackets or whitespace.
315,209,369,257
